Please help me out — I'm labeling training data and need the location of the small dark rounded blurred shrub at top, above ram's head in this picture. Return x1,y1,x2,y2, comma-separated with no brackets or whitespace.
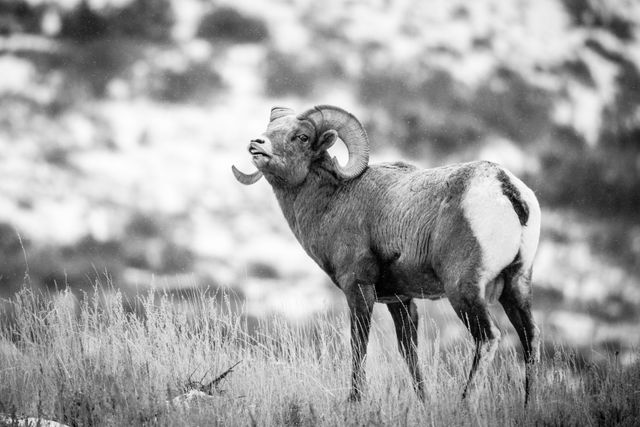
196,7,269,43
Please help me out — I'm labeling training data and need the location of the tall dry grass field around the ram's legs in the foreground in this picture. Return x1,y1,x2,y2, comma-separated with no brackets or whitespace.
0,289,640,426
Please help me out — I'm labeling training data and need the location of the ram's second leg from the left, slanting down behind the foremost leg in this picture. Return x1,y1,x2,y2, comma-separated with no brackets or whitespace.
387,300,424,400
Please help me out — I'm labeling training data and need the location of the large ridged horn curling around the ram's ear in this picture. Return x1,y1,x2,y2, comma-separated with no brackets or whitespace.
298,105,369,179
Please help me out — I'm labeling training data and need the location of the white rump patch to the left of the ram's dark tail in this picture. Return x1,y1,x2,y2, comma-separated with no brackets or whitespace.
462,175,524,283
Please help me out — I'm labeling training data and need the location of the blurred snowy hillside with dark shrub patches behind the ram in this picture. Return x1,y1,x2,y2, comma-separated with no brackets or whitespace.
0,0,640,362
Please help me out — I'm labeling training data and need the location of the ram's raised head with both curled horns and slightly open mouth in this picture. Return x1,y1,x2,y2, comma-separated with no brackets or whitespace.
232,105,369,186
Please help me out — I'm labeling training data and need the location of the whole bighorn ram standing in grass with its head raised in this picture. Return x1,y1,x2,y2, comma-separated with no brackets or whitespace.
232,105,540,402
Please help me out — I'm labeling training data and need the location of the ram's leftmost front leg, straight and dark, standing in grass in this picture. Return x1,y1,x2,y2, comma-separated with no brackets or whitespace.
344,281,375,401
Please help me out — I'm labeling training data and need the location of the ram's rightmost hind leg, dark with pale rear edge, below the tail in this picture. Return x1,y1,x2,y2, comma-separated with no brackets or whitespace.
500,265,540,405
